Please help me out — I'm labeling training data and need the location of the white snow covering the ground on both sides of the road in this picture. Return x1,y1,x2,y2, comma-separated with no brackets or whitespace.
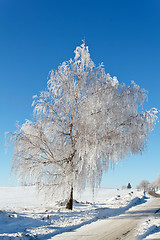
0,187,160,240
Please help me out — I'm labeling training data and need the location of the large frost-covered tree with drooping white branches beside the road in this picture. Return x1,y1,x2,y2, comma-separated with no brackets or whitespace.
12,43,157,209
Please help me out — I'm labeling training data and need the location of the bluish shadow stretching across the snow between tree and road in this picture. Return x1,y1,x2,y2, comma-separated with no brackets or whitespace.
0,197,147,240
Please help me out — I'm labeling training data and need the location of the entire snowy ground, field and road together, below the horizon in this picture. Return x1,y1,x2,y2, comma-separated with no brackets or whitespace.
0,187,160,240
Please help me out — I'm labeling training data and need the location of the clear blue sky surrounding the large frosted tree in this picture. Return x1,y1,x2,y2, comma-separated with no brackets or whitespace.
0,0,160,188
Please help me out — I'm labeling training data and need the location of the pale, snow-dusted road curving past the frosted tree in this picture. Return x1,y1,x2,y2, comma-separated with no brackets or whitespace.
53,197,160,240
